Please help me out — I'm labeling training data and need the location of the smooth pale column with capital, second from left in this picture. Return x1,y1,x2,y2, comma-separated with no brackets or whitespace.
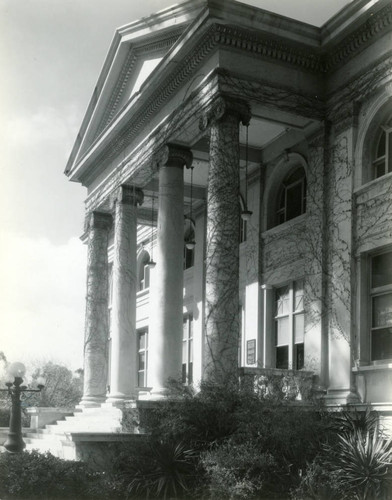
108,185,143,403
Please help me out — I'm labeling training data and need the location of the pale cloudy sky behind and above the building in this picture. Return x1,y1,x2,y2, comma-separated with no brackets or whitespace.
0,0,356,370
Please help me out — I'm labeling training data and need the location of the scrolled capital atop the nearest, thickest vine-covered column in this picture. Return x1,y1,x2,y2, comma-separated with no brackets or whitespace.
199,95,252,132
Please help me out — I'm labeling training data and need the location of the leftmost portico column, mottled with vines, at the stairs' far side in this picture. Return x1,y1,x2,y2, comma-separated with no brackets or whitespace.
80,212,112,406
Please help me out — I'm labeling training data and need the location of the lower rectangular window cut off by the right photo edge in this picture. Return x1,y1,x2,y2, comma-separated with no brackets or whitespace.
370,252,392,361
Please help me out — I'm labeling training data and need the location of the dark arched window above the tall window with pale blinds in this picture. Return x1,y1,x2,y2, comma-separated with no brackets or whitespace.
276,167,306,225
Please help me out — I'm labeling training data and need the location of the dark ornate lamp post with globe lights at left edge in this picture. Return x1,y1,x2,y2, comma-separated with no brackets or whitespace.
0,362,45,453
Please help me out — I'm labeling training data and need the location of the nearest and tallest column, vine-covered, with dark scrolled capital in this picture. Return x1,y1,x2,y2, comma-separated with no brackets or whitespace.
200,97,250,382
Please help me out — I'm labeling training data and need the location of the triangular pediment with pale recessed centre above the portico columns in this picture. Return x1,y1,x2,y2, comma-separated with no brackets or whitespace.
66,0,208,172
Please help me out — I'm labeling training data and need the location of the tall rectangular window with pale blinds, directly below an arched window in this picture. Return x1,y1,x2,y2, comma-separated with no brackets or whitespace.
275,280,305,370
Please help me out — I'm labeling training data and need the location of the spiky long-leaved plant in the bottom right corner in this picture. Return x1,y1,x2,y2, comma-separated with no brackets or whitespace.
293,411,392,500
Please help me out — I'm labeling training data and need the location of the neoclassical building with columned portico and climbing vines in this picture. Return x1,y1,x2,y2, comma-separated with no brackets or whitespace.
65,0,392,415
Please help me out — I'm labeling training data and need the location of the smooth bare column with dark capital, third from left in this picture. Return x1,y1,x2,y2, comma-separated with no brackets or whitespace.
148,144,192,397
